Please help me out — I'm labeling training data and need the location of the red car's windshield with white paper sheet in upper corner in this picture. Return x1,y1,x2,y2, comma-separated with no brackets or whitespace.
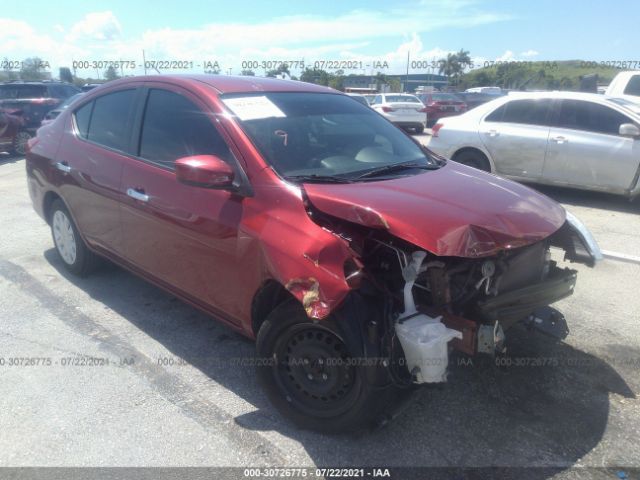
222,92,440,182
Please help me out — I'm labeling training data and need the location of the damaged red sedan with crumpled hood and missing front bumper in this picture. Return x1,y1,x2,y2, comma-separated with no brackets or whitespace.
27,75,601,431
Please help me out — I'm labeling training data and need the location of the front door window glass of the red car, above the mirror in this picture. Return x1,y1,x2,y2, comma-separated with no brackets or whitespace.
140,89,231,168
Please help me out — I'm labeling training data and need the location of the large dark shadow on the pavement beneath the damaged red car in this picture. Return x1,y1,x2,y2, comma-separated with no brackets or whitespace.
45,249,640,479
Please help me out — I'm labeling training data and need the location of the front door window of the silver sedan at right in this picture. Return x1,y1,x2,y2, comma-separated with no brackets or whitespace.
555,100,632,135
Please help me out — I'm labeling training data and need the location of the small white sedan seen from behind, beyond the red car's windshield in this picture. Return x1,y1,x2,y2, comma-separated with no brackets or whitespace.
371,93,427,133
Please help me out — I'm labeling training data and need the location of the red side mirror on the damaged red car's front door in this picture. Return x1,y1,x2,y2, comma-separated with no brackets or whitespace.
175,155,234,189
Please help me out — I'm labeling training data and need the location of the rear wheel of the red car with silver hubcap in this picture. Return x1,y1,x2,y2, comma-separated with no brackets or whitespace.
50,200,98,276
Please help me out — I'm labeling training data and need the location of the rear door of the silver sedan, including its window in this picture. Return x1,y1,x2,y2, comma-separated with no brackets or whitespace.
479,98,552,180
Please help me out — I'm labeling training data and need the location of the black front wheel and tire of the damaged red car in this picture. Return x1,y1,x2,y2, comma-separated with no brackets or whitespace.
257,300,412,433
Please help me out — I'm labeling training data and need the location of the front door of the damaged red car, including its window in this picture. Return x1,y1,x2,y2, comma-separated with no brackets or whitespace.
121,84,249,321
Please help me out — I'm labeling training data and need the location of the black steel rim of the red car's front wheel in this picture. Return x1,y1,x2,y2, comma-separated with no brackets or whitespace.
276,325,357,417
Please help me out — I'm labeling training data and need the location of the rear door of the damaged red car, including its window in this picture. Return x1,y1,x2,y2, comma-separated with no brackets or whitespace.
53,87,137,255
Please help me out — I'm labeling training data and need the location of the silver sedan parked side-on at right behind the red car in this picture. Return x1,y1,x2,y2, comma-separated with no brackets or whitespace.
429,92,640,197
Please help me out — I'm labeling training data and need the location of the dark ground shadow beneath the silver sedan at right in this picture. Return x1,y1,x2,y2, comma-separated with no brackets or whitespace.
529,184,640,213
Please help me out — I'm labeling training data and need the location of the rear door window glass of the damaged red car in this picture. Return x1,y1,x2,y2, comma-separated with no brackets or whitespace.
85,90,135,150
